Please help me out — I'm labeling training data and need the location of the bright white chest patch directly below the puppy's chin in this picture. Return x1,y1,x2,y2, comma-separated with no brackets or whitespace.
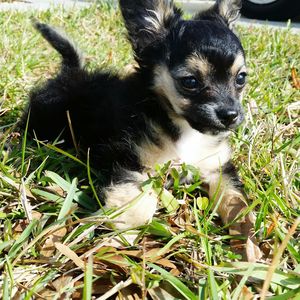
175,126,231,175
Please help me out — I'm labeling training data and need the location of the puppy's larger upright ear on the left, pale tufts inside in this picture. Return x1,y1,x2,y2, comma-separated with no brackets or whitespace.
119,0,182,55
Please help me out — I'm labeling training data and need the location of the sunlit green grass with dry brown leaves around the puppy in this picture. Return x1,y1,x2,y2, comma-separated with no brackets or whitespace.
0,5,300,299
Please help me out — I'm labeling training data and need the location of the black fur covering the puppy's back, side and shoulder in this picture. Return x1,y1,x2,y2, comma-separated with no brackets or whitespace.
24,54,179,175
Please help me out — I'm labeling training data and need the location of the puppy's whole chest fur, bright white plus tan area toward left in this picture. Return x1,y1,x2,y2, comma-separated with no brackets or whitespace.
135,121,231,177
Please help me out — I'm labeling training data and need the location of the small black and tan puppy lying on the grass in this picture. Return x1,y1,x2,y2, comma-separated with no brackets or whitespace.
24,0,260,261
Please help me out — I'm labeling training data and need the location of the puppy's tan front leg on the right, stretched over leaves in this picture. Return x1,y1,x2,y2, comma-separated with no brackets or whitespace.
209,162,262,262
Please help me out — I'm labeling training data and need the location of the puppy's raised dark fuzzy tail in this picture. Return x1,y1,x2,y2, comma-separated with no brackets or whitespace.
34,21,82,68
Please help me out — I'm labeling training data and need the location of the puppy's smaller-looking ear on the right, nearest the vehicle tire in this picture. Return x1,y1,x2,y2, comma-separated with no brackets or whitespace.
194,0,242,28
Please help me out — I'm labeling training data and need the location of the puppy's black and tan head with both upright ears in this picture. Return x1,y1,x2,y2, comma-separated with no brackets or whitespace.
120,0,246,133
